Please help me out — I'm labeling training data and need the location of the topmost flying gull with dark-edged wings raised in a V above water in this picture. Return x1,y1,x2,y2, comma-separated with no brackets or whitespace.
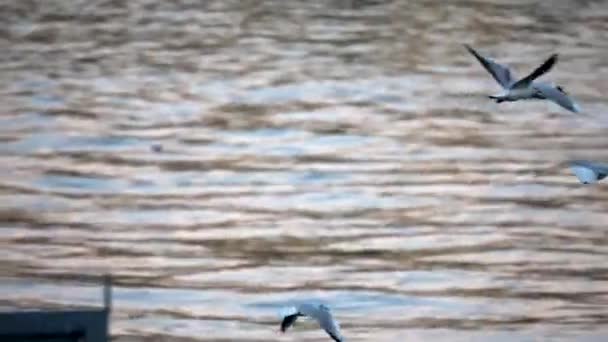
464,44,580,113
